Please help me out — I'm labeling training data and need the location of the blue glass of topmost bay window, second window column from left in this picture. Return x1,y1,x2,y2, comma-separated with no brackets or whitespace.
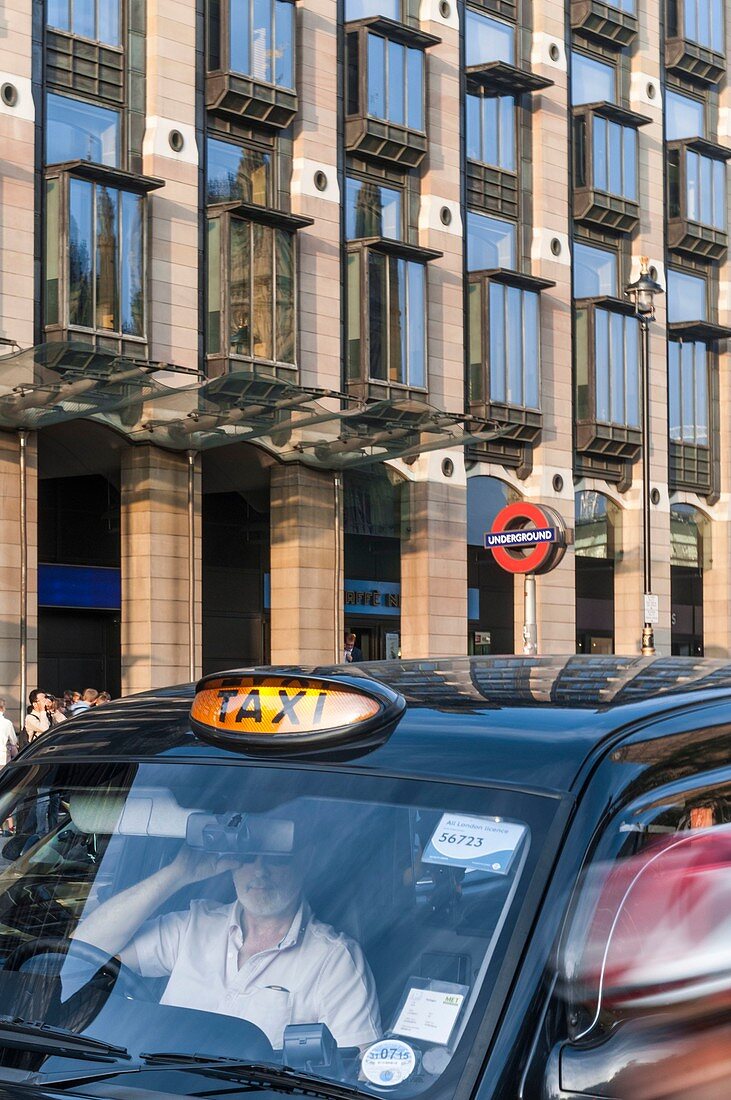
230,0,295,88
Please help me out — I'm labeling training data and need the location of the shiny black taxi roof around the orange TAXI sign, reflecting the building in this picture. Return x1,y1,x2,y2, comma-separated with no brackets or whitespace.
20,656,731,791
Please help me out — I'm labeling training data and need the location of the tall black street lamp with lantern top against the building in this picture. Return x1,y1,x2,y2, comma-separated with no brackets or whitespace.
624,256,663,657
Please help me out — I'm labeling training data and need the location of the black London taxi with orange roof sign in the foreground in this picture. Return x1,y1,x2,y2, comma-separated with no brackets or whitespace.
0,657,731,1100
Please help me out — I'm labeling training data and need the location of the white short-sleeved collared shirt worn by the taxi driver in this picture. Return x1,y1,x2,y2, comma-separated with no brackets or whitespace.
130,901,380,1048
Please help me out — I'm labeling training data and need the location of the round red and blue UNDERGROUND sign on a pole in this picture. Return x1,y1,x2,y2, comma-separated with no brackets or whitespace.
485,501,566,573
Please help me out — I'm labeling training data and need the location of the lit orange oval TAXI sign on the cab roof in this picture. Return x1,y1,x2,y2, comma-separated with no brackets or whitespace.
190,672,406,749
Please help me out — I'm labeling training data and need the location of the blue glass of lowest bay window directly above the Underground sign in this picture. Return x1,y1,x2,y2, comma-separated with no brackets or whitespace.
489,283,540,409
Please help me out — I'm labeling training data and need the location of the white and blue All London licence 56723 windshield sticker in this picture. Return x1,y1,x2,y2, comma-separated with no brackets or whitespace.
421,814,525,875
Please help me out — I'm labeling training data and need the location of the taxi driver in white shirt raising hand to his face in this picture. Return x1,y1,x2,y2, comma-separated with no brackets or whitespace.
75,815,380,1047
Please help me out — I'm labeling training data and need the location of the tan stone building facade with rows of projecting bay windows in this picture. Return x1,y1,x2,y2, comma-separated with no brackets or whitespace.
0,0,731,700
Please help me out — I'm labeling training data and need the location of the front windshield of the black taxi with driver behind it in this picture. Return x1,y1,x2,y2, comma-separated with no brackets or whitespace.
0,758,555,1096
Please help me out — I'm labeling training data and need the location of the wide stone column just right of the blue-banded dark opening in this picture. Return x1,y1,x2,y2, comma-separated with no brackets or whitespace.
121,447,201,694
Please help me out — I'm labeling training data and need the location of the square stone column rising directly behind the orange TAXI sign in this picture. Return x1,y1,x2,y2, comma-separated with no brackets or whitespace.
270,464,343,664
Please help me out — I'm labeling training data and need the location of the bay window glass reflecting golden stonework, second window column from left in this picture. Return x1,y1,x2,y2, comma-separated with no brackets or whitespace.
220,218,296,364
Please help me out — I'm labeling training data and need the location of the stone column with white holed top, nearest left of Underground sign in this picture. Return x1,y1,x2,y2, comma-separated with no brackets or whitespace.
401,451,467,658
